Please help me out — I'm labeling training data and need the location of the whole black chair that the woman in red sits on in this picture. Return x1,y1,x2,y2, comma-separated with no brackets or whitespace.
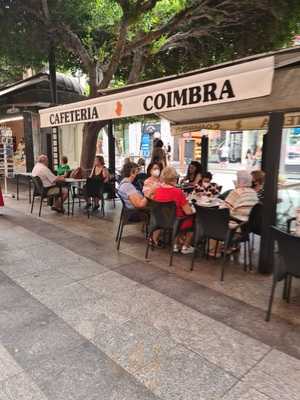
145,200,191,266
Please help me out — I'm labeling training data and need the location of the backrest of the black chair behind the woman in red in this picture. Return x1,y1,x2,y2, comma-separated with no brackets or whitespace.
148,200,176,232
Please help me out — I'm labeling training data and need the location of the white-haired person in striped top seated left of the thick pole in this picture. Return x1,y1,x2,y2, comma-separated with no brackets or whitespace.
225,171,258,222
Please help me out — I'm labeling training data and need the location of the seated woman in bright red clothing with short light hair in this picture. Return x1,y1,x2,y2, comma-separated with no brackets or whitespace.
153,167,194,254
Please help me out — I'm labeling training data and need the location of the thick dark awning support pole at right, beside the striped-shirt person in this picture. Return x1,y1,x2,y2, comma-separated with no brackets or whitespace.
258,112,284,273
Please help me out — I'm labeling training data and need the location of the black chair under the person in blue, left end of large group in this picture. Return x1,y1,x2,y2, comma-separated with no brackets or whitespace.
116,190,149,250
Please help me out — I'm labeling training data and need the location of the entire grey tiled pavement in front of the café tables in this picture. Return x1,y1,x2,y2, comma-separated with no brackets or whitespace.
0,191,300,400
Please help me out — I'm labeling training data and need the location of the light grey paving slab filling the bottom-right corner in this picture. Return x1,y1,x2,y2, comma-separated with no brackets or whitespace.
243,350,300,400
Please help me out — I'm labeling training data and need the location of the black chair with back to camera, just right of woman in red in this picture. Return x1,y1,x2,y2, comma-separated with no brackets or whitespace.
191,205,246,281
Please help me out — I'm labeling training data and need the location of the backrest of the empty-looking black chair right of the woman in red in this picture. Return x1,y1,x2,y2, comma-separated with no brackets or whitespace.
195,205,230,241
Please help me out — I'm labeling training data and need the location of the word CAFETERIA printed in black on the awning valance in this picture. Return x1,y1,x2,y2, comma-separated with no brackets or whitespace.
49,107,99,125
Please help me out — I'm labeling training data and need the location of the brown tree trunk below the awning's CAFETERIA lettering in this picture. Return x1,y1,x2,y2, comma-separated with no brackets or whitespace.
80,121,107,176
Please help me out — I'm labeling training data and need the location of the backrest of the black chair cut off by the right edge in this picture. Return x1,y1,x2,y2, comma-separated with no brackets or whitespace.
271,226,300,280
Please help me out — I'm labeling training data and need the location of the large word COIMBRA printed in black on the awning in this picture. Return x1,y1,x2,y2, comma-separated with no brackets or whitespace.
143,79,236,111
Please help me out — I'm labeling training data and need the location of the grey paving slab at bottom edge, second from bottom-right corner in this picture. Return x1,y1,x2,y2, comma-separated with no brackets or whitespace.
135,346,237,400
